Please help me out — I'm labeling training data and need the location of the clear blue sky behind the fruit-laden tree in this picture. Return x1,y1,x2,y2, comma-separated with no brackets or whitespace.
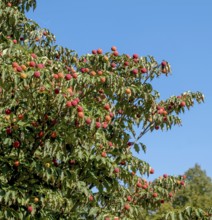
28,0,212,178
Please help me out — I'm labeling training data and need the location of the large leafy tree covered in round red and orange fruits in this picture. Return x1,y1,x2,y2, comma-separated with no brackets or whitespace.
0,0,205,220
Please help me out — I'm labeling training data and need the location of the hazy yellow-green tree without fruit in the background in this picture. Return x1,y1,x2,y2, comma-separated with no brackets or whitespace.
146,164,212,220
